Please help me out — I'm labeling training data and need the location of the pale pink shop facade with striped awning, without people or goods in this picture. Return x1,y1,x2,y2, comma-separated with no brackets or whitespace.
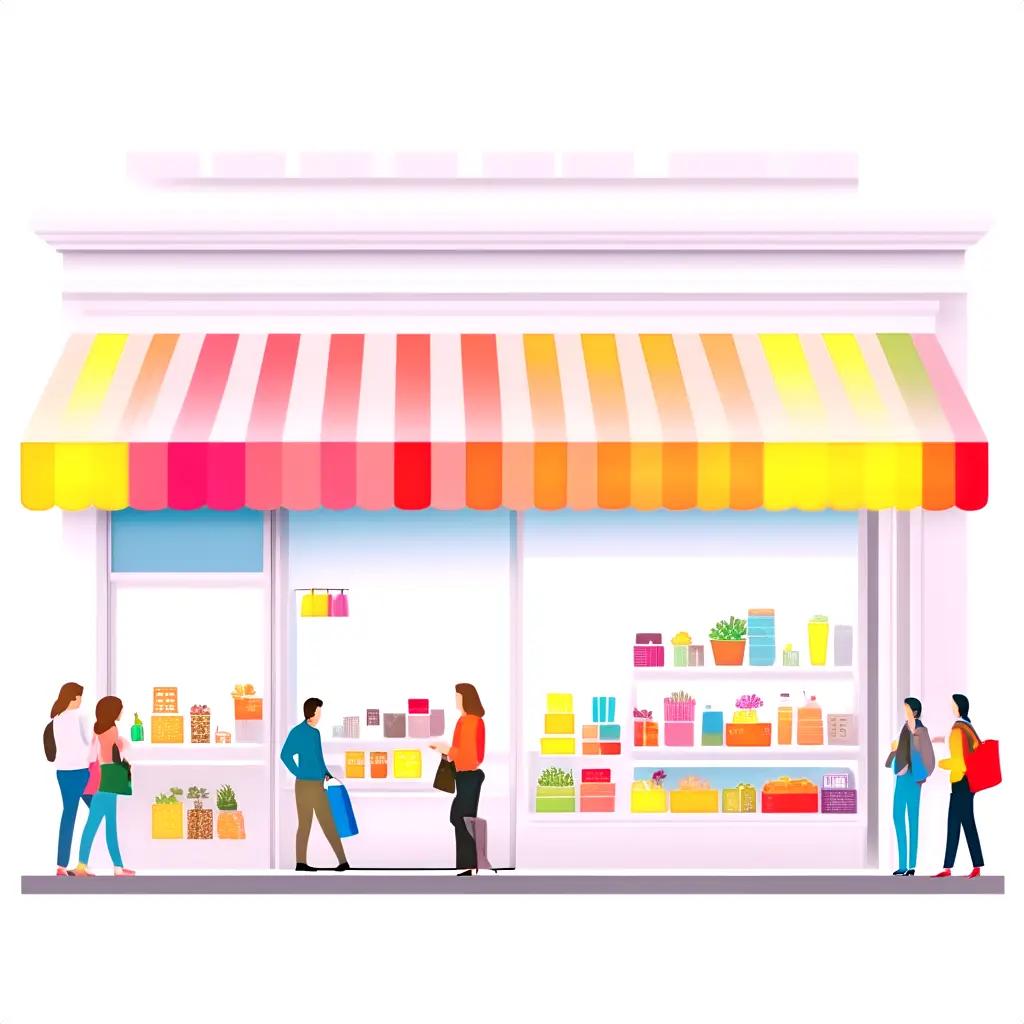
23,151,987,870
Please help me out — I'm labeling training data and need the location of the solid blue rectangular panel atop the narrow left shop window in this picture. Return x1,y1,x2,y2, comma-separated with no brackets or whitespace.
111,509,263,572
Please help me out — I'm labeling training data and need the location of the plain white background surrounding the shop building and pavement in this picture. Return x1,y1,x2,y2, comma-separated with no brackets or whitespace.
0,0,1024,1024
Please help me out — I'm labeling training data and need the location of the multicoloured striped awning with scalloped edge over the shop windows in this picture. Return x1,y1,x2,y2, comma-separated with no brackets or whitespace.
22,334,988,509
